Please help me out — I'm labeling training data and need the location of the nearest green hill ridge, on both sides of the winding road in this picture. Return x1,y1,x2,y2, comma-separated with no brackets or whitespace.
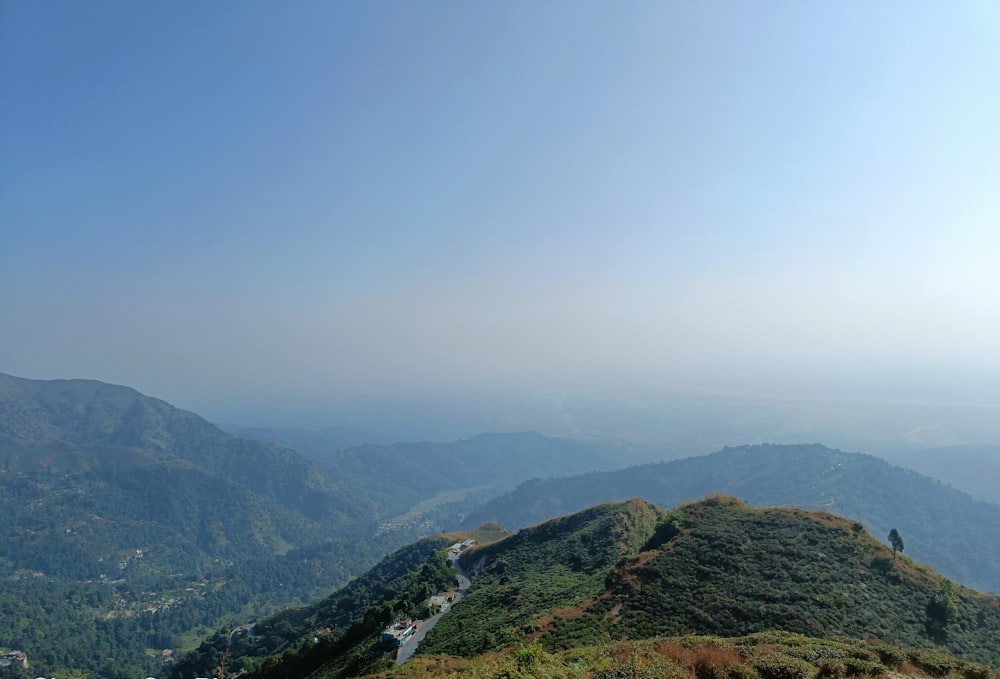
174,496,1000,679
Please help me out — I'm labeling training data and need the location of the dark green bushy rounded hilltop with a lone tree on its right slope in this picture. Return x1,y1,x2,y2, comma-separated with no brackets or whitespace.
580,498,1000,664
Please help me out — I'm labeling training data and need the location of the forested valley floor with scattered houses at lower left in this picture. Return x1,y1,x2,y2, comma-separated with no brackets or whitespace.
0,524,422,679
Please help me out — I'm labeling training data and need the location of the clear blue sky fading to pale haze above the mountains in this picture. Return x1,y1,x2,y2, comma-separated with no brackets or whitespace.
0,0,1000,422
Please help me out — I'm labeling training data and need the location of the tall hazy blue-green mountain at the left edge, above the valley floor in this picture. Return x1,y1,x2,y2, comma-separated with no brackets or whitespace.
0,375,376,578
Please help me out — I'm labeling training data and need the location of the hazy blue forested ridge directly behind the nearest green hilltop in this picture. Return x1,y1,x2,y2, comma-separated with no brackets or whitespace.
466,444,1000,592
